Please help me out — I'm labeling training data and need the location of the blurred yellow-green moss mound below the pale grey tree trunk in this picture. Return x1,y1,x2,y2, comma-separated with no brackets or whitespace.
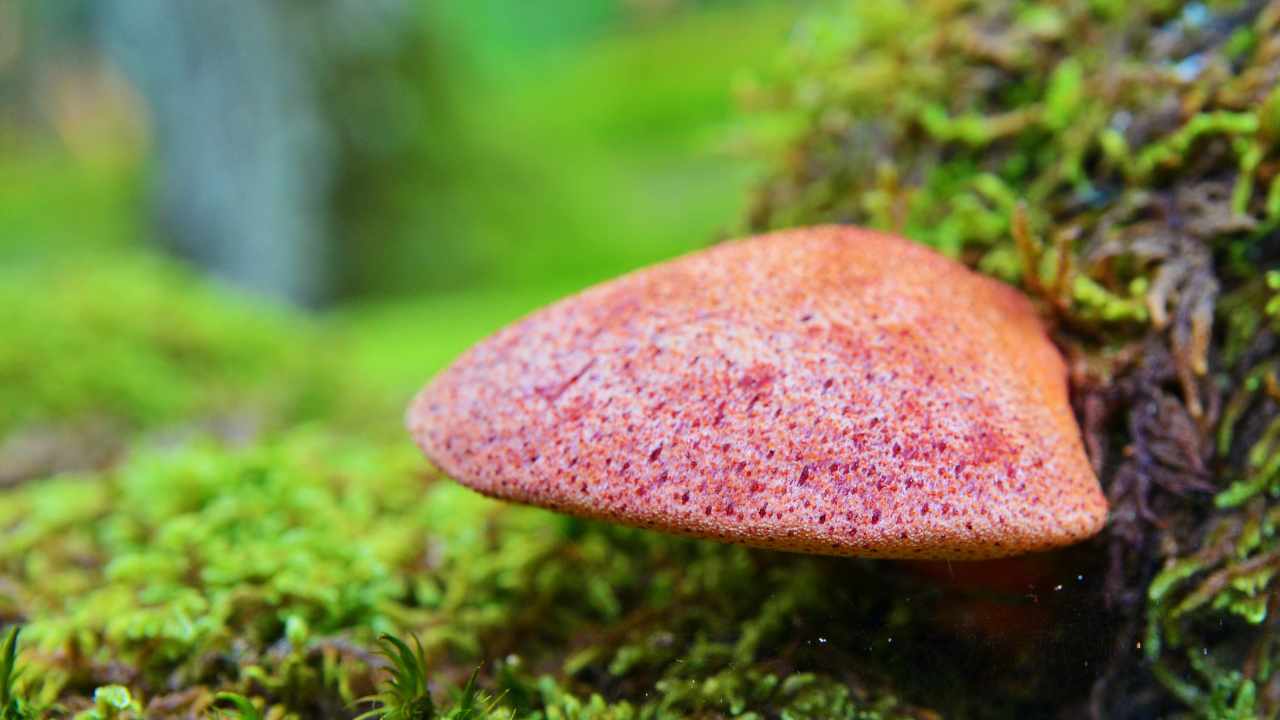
0,251,373,484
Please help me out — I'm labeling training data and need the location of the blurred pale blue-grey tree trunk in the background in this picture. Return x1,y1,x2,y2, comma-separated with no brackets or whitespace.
100,0,334,305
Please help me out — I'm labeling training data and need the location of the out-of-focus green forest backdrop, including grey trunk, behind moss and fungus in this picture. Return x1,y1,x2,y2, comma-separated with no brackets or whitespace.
0,0,808,391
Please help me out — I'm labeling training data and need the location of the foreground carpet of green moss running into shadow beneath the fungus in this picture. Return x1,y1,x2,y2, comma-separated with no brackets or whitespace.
0,420,931,717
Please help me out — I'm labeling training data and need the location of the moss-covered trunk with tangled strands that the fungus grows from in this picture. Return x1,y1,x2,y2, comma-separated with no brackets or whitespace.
750,0,1280,717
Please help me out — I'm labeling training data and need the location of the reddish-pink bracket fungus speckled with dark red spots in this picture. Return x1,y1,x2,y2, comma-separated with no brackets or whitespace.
407,227,1107,560
